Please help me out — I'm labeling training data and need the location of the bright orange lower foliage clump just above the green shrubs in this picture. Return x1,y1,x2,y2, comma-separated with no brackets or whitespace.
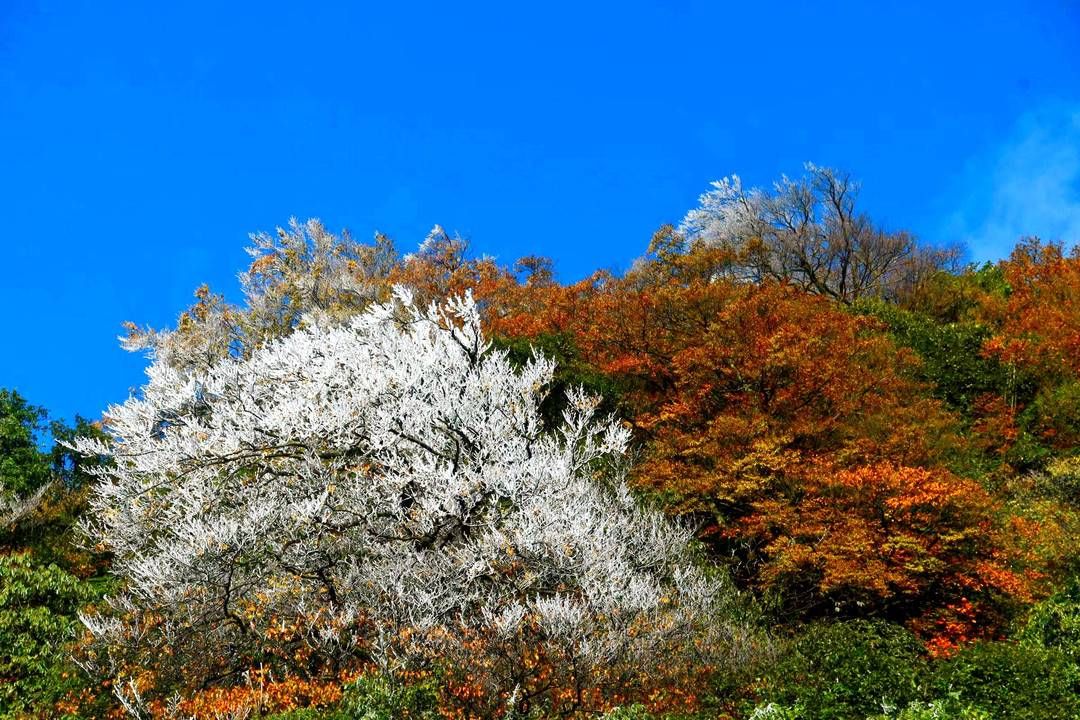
741,463,1031,637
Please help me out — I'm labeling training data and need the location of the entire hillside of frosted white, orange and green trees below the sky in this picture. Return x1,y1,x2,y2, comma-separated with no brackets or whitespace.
0,165,1080,720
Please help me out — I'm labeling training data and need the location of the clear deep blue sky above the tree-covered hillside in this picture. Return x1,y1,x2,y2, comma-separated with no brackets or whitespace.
0,0,1080,425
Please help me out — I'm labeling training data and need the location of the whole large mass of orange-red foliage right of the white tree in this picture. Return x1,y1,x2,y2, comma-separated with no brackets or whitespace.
492,235,1028,639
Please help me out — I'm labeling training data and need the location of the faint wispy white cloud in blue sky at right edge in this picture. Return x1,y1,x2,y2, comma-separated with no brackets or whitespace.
946,105,1080,261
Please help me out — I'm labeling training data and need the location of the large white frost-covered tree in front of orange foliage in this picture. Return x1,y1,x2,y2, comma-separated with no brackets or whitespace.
78,289,739,716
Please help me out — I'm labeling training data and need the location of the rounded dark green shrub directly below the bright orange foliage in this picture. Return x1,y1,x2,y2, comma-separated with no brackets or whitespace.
755,620,928,720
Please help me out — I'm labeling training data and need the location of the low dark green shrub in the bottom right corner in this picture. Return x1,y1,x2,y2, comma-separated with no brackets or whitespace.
933,642,1080,720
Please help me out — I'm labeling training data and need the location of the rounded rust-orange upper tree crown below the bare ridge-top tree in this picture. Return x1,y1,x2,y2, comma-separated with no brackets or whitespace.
639,285,951,507
